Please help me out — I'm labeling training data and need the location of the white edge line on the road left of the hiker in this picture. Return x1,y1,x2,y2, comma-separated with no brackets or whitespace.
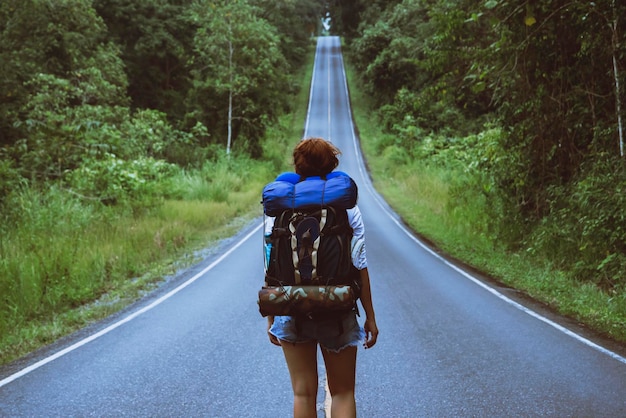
0,224,263,387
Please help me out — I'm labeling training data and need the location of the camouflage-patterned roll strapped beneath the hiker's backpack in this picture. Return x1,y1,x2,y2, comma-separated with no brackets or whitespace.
258,285,356,316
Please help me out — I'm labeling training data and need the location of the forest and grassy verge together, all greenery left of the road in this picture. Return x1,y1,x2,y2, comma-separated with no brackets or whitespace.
0,0,324,355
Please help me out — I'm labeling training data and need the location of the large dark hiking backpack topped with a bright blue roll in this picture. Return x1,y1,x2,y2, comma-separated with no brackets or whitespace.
263,172,358,316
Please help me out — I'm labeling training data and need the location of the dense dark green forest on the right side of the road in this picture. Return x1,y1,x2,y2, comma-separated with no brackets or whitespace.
331,0,626,298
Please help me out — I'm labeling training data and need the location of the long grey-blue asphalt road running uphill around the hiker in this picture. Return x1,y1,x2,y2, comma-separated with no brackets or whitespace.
0,37,626,418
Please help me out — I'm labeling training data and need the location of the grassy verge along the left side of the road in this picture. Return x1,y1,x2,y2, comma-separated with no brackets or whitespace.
0,43,315,364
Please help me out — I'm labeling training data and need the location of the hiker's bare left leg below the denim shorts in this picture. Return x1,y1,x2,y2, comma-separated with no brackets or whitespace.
281,341,317,418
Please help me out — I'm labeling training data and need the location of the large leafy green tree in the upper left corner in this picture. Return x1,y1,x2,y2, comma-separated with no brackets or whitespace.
0,0,127,179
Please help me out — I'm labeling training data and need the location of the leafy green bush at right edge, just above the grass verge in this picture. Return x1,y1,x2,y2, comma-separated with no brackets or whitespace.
529,154,626,289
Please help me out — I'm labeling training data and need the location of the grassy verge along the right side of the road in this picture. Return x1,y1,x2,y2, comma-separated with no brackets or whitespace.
346,63,626,342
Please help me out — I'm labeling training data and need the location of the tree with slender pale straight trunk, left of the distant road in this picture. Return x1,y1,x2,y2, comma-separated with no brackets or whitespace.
189,0,289,155
